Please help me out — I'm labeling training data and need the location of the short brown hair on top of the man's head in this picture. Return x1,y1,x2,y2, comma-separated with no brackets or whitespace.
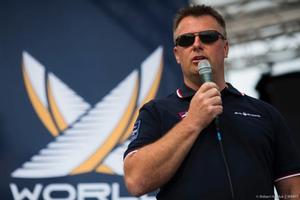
173,4,227,37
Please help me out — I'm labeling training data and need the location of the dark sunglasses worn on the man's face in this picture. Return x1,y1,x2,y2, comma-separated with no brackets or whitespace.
175,30,226,47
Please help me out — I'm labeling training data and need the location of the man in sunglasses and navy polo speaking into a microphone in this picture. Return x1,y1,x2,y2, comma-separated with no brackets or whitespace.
124,5,300,200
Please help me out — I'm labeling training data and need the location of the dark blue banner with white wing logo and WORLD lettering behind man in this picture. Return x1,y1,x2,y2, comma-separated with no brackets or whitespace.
0,0,187,200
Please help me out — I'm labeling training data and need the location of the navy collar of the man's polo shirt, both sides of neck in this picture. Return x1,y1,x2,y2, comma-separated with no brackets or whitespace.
176,83,244,99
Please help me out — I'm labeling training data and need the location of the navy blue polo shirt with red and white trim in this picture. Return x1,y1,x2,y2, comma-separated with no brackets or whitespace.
124,84,300,200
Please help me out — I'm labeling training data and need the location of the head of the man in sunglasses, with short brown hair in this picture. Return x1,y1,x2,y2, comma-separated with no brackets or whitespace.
173,5,228,88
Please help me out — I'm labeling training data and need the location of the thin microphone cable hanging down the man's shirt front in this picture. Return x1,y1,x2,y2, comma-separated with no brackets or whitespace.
214,116,235,200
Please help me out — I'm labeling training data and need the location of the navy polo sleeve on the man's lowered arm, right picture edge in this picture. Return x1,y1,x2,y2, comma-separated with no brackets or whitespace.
274,107,300,182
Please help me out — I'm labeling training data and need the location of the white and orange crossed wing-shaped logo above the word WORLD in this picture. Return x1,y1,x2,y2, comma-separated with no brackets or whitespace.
12,47,163,178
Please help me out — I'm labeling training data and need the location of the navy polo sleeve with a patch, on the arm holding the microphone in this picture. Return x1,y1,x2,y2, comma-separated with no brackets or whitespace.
123,101,161,158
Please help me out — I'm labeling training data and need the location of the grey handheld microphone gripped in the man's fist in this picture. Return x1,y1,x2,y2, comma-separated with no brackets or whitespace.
197,59,221,134
